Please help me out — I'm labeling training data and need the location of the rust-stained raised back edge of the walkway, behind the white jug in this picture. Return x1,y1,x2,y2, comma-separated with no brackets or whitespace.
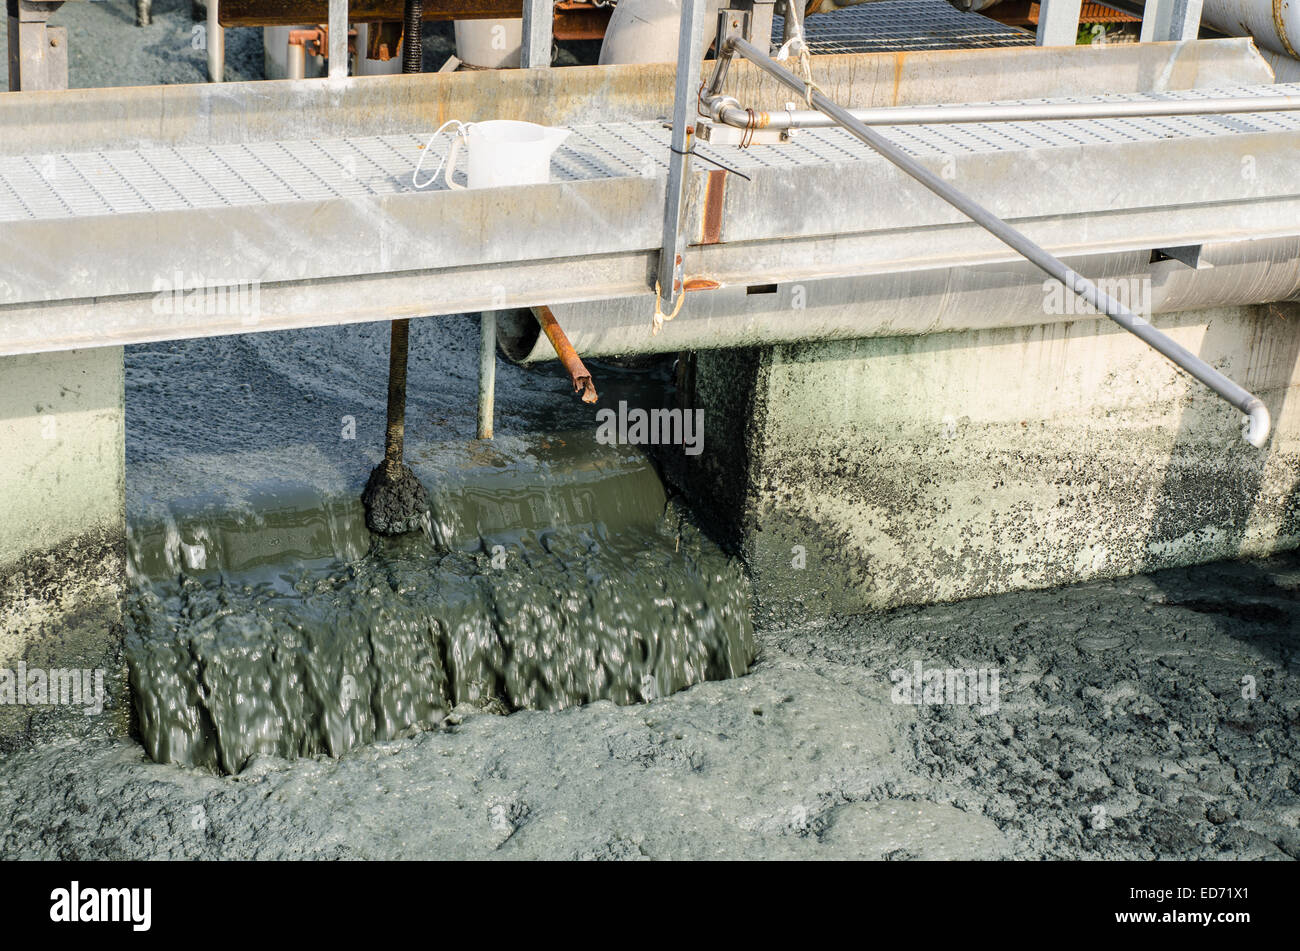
0,39,1273,155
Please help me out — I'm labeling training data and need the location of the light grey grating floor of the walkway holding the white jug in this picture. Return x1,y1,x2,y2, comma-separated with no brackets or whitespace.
0,83,1300,221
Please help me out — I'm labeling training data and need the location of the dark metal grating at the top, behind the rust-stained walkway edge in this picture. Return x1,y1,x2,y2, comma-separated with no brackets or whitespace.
772,0,1034,53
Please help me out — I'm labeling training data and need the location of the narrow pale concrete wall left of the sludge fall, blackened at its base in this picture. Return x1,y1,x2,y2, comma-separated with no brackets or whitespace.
0,347,129,750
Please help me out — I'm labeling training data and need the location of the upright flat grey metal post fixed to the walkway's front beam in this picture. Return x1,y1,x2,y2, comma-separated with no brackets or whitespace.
658,0,709,313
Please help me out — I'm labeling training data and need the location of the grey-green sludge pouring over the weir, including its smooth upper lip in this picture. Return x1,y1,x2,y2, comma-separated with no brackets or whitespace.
127,329,754,773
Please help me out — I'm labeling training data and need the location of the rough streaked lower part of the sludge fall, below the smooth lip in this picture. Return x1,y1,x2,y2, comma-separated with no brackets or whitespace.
127,514,754,773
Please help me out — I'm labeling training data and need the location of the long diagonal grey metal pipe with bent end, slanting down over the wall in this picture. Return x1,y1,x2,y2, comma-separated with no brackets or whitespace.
728,36,1271,447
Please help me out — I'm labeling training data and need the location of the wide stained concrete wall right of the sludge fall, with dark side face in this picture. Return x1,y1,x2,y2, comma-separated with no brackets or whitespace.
670,304,1300,615
